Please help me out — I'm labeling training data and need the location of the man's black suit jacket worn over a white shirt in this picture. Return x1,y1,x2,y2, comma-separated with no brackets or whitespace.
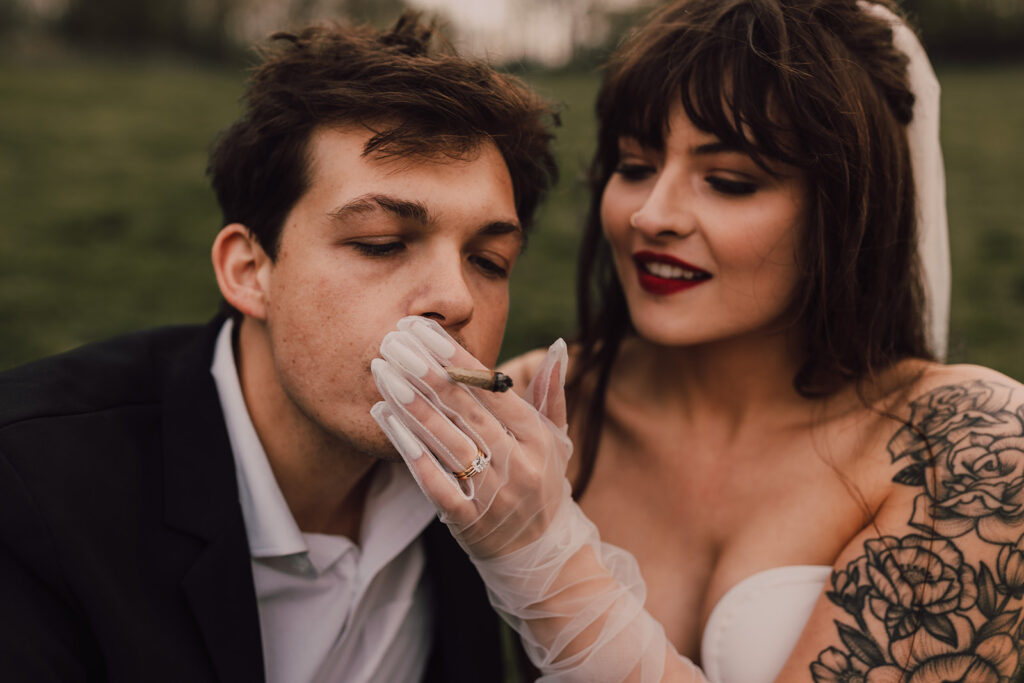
0,318,503,683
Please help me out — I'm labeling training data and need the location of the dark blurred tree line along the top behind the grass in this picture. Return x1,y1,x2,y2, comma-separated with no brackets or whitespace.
0,0,1024,69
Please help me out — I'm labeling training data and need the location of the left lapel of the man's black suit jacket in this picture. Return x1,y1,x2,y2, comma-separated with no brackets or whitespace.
163,318,264,681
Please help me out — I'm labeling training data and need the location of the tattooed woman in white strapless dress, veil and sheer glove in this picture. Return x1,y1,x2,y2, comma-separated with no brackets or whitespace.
374,0,1024,683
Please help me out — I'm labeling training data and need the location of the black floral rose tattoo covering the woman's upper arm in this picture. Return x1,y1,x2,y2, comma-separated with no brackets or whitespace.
810,380,1024,683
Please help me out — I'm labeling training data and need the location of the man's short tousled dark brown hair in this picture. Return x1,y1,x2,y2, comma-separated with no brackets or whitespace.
207,12,557,259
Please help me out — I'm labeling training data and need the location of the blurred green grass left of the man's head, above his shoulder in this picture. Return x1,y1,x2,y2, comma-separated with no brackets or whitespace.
0,61,241,368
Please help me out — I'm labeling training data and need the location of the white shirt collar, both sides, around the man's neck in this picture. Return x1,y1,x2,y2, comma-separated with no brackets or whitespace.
210,321,434,575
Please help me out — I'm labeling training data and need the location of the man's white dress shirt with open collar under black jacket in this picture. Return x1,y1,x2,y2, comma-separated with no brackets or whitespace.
210,321,434,683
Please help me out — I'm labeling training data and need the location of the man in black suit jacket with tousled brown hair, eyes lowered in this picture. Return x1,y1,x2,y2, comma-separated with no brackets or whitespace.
0,16,554,683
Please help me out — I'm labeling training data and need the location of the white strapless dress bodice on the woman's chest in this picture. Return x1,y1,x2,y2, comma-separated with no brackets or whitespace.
700,565,833,683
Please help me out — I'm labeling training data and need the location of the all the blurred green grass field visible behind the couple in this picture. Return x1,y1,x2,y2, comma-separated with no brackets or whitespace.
0,60,1024,378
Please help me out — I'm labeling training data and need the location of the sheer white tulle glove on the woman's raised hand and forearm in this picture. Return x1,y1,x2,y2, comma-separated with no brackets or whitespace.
372,317,703,683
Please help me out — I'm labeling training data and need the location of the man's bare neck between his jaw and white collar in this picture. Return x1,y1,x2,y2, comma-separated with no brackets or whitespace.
234,319,377,543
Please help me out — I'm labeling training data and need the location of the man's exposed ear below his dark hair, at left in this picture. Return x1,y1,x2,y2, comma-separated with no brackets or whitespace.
210,223,272,321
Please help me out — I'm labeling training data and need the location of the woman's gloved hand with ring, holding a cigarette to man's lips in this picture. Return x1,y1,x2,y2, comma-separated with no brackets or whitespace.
372,317,572,559
